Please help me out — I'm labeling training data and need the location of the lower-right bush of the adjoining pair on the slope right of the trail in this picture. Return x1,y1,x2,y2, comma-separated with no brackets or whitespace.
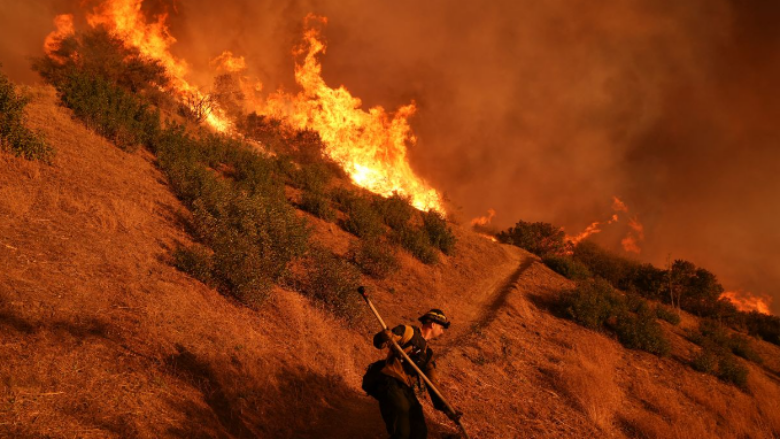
615,305,672,357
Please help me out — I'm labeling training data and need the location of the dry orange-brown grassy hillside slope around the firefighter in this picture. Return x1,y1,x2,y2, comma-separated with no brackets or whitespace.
0,88,780,439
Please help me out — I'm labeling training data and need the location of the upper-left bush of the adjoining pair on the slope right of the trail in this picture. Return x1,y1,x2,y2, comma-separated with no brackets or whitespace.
561,278,627,330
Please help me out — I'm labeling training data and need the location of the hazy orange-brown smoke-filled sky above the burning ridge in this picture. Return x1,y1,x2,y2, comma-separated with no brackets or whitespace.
0,0,780,312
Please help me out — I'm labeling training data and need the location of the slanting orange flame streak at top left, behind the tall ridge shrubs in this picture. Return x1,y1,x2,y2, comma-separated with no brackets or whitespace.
87,0,231,132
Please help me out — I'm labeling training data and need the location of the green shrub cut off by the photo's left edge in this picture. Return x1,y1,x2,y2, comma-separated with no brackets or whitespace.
0,72,54,163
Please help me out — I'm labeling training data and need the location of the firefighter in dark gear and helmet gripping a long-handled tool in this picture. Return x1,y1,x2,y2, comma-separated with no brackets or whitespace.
371,309,460,439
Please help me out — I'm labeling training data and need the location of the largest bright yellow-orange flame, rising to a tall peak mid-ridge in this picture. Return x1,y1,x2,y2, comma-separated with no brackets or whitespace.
258,15,445,213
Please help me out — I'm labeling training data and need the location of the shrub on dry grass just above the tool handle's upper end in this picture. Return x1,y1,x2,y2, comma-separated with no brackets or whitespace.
303,249,365,321
